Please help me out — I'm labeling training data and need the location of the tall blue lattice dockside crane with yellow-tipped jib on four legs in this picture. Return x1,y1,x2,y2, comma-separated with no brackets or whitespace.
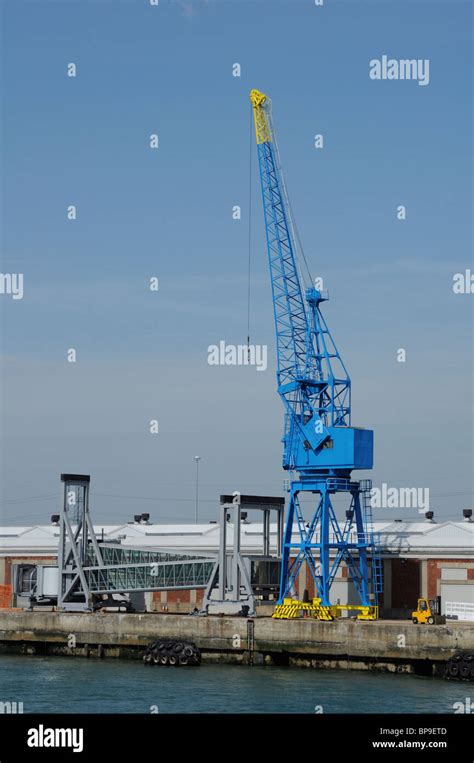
250,90,382,619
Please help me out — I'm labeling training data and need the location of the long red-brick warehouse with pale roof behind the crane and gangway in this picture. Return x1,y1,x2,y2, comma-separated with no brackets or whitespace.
0,512,474,618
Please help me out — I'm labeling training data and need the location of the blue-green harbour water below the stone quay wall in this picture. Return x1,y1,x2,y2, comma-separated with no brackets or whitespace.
0,655,466,713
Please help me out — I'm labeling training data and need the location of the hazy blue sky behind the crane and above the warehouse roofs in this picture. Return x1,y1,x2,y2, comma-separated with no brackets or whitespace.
0,0,474,523
